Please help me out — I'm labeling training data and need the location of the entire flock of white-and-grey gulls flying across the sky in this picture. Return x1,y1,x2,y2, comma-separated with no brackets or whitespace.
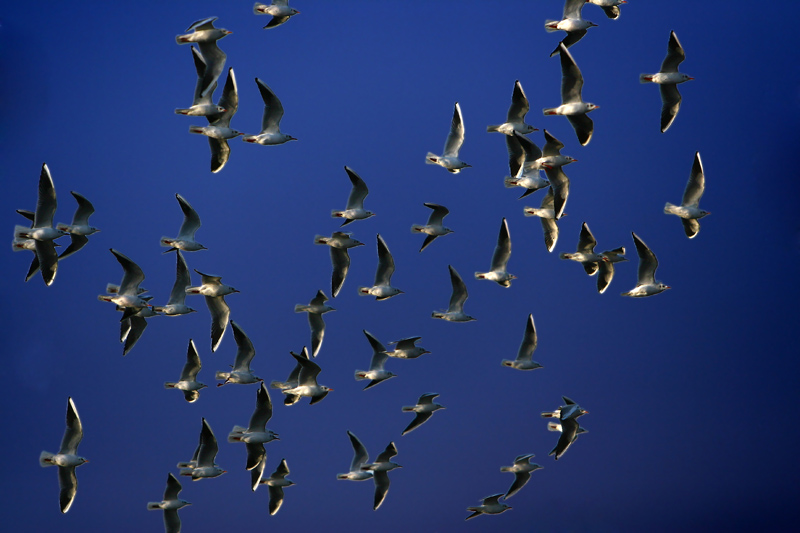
17,0,708,533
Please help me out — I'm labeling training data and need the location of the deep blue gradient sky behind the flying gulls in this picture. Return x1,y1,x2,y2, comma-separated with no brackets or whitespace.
0,0,800,532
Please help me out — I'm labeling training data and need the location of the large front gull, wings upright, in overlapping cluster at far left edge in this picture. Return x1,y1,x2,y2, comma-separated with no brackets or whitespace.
14,163,67,287
